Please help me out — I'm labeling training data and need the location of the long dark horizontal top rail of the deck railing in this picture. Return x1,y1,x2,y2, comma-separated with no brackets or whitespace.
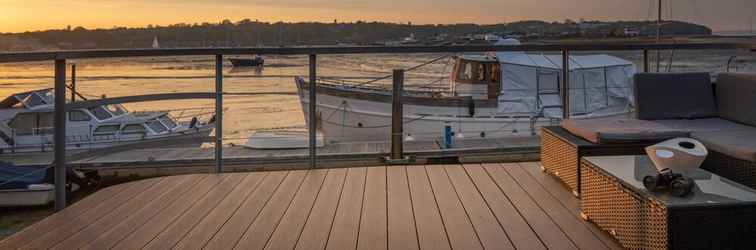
0,43,756,63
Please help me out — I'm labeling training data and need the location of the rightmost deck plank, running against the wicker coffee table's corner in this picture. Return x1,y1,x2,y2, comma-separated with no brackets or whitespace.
519,162,624,250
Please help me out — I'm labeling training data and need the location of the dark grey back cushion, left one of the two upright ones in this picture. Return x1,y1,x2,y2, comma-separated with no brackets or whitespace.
635,73,718,120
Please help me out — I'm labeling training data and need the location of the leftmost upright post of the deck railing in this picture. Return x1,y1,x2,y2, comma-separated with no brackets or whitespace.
53,59,66,211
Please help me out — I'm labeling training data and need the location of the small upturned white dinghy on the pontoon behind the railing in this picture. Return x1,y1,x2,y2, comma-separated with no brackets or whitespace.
243,131,325,149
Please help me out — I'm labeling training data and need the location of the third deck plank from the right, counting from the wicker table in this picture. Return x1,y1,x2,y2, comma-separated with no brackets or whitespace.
483,164,577,249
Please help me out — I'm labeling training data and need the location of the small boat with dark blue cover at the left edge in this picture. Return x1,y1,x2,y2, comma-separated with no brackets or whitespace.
0,162,86,207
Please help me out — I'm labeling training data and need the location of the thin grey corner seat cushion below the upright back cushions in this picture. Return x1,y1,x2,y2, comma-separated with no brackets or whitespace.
654,118,752,132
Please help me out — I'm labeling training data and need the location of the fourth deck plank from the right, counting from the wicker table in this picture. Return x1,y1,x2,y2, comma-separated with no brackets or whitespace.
464,164,546,249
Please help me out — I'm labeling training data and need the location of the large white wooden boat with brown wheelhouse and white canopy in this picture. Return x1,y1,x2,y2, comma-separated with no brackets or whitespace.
295,39,636,143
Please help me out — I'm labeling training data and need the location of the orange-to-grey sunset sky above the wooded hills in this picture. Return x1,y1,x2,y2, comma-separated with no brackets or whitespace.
0,0,756,32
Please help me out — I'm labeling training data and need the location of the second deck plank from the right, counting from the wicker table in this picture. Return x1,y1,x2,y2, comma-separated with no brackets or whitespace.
501,164,608,249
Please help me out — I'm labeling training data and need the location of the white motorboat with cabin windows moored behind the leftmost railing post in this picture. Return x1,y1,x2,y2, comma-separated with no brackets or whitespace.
0,89,215,153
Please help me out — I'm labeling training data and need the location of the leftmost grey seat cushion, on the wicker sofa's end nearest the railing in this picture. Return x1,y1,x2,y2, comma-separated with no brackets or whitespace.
562,118,690,144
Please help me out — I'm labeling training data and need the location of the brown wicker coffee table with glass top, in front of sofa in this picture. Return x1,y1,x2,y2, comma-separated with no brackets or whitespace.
580,156,756,249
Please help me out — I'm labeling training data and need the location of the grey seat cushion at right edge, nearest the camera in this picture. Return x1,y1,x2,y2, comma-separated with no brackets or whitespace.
691,128,756,162
